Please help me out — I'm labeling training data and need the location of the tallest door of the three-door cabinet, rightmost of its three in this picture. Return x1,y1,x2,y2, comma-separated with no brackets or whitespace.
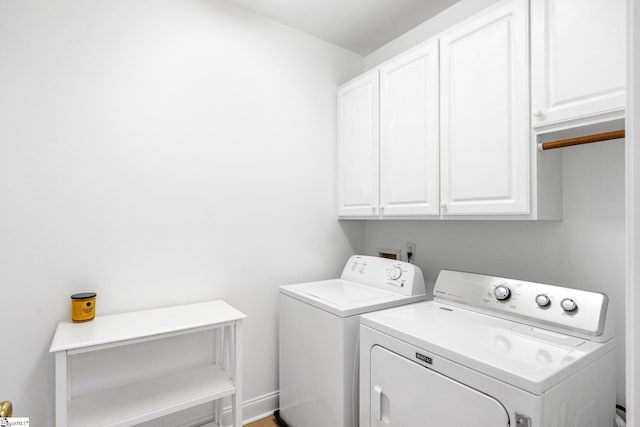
440,0,530,215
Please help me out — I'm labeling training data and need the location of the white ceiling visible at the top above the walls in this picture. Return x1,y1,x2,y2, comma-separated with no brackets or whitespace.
220,0,458,55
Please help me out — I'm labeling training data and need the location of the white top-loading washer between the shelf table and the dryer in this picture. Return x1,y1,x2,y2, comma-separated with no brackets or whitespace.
276,255,426,427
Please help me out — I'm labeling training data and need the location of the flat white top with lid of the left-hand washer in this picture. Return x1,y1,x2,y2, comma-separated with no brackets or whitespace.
280,279,425,317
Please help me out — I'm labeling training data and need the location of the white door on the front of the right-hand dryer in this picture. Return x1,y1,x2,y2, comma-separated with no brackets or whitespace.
370,346,509,427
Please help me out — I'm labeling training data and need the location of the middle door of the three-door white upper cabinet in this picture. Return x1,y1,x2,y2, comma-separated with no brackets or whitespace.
380,41,440,217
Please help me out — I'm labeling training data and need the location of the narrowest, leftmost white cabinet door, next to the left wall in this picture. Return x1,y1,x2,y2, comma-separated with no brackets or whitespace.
338,70,379,217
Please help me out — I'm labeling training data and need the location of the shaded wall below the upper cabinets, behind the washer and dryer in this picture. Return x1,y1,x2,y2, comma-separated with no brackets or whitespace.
366,141,625,404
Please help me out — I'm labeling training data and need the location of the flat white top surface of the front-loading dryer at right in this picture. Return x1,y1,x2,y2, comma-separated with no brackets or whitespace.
361,301,614,395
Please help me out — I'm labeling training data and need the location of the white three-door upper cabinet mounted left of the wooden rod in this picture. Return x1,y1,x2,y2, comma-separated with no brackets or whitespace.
338,0,564,220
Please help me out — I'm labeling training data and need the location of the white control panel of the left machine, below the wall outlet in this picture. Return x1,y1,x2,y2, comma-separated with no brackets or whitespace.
340,255,425,296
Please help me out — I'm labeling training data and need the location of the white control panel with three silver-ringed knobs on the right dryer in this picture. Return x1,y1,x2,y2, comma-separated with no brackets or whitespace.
433,270,609,338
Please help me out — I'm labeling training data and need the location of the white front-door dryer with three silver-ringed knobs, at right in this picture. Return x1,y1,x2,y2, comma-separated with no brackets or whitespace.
360,270,616,427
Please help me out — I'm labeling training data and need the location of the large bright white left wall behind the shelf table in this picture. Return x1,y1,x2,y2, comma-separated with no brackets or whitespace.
0,0,364,426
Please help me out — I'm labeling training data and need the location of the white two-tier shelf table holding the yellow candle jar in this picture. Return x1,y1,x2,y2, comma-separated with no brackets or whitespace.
50,300,246,427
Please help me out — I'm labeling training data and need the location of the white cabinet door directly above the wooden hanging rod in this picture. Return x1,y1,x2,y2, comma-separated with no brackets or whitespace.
531,0,626,126
